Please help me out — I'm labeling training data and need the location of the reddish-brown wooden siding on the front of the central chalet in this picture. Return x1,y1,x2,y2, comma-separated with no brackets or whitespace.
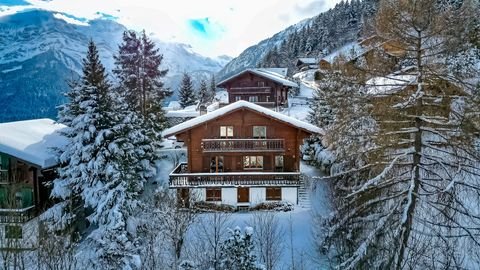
177,109,310,173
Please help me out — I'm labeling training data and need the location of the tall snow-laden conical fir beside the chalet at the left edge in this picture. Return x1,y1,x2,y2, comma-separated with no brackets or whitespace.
51,42,148,269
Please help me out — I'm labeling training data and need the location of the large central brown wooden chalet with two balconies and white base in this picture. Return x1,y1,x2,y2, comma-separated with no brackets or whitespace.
163,101,322,207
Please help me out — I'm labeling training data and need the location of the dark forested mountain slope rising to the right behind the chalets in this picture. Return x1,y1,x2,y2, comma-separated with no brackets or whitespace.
218,0,378,78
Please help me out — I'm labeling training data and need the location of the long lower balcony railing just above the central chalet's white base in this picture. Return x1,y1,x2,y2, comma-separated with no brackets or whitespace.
170,163,300,187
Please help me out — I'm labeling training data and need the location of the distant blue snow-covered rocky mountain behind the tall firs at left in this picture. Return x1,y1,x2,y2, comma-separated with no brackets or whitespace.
0,10,228,122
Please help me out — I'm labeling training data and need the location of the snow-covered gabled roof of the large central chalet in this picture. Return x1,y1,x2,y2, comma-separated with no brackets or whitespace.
163,100,323,137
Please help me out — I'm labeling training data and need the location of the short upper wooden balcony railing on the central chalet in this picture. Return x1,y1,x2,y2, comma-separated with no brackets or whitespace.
202,139,285,153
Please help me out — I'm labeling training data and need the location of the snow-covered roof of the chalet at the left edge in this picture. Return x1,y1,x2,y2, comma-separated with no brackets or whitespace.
0,119,68,168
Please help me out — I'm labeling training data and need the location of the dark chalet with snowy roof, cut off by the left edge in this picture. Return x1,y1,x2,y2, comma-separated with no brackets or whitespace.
0,119,66,248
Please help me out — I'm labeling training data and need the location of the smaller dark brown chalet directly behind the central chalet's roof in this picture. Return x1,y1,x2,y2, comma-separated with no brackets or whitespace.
217,68,299,108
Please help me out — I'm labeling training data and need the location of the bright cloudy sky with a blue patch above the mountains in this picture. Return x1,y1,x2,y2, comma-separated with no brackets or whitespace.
0,0,340,57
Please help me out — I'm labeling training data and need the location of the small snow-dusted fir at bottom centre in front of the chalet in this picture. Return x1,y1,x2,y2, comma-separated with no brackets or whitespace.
218,227,265,270
